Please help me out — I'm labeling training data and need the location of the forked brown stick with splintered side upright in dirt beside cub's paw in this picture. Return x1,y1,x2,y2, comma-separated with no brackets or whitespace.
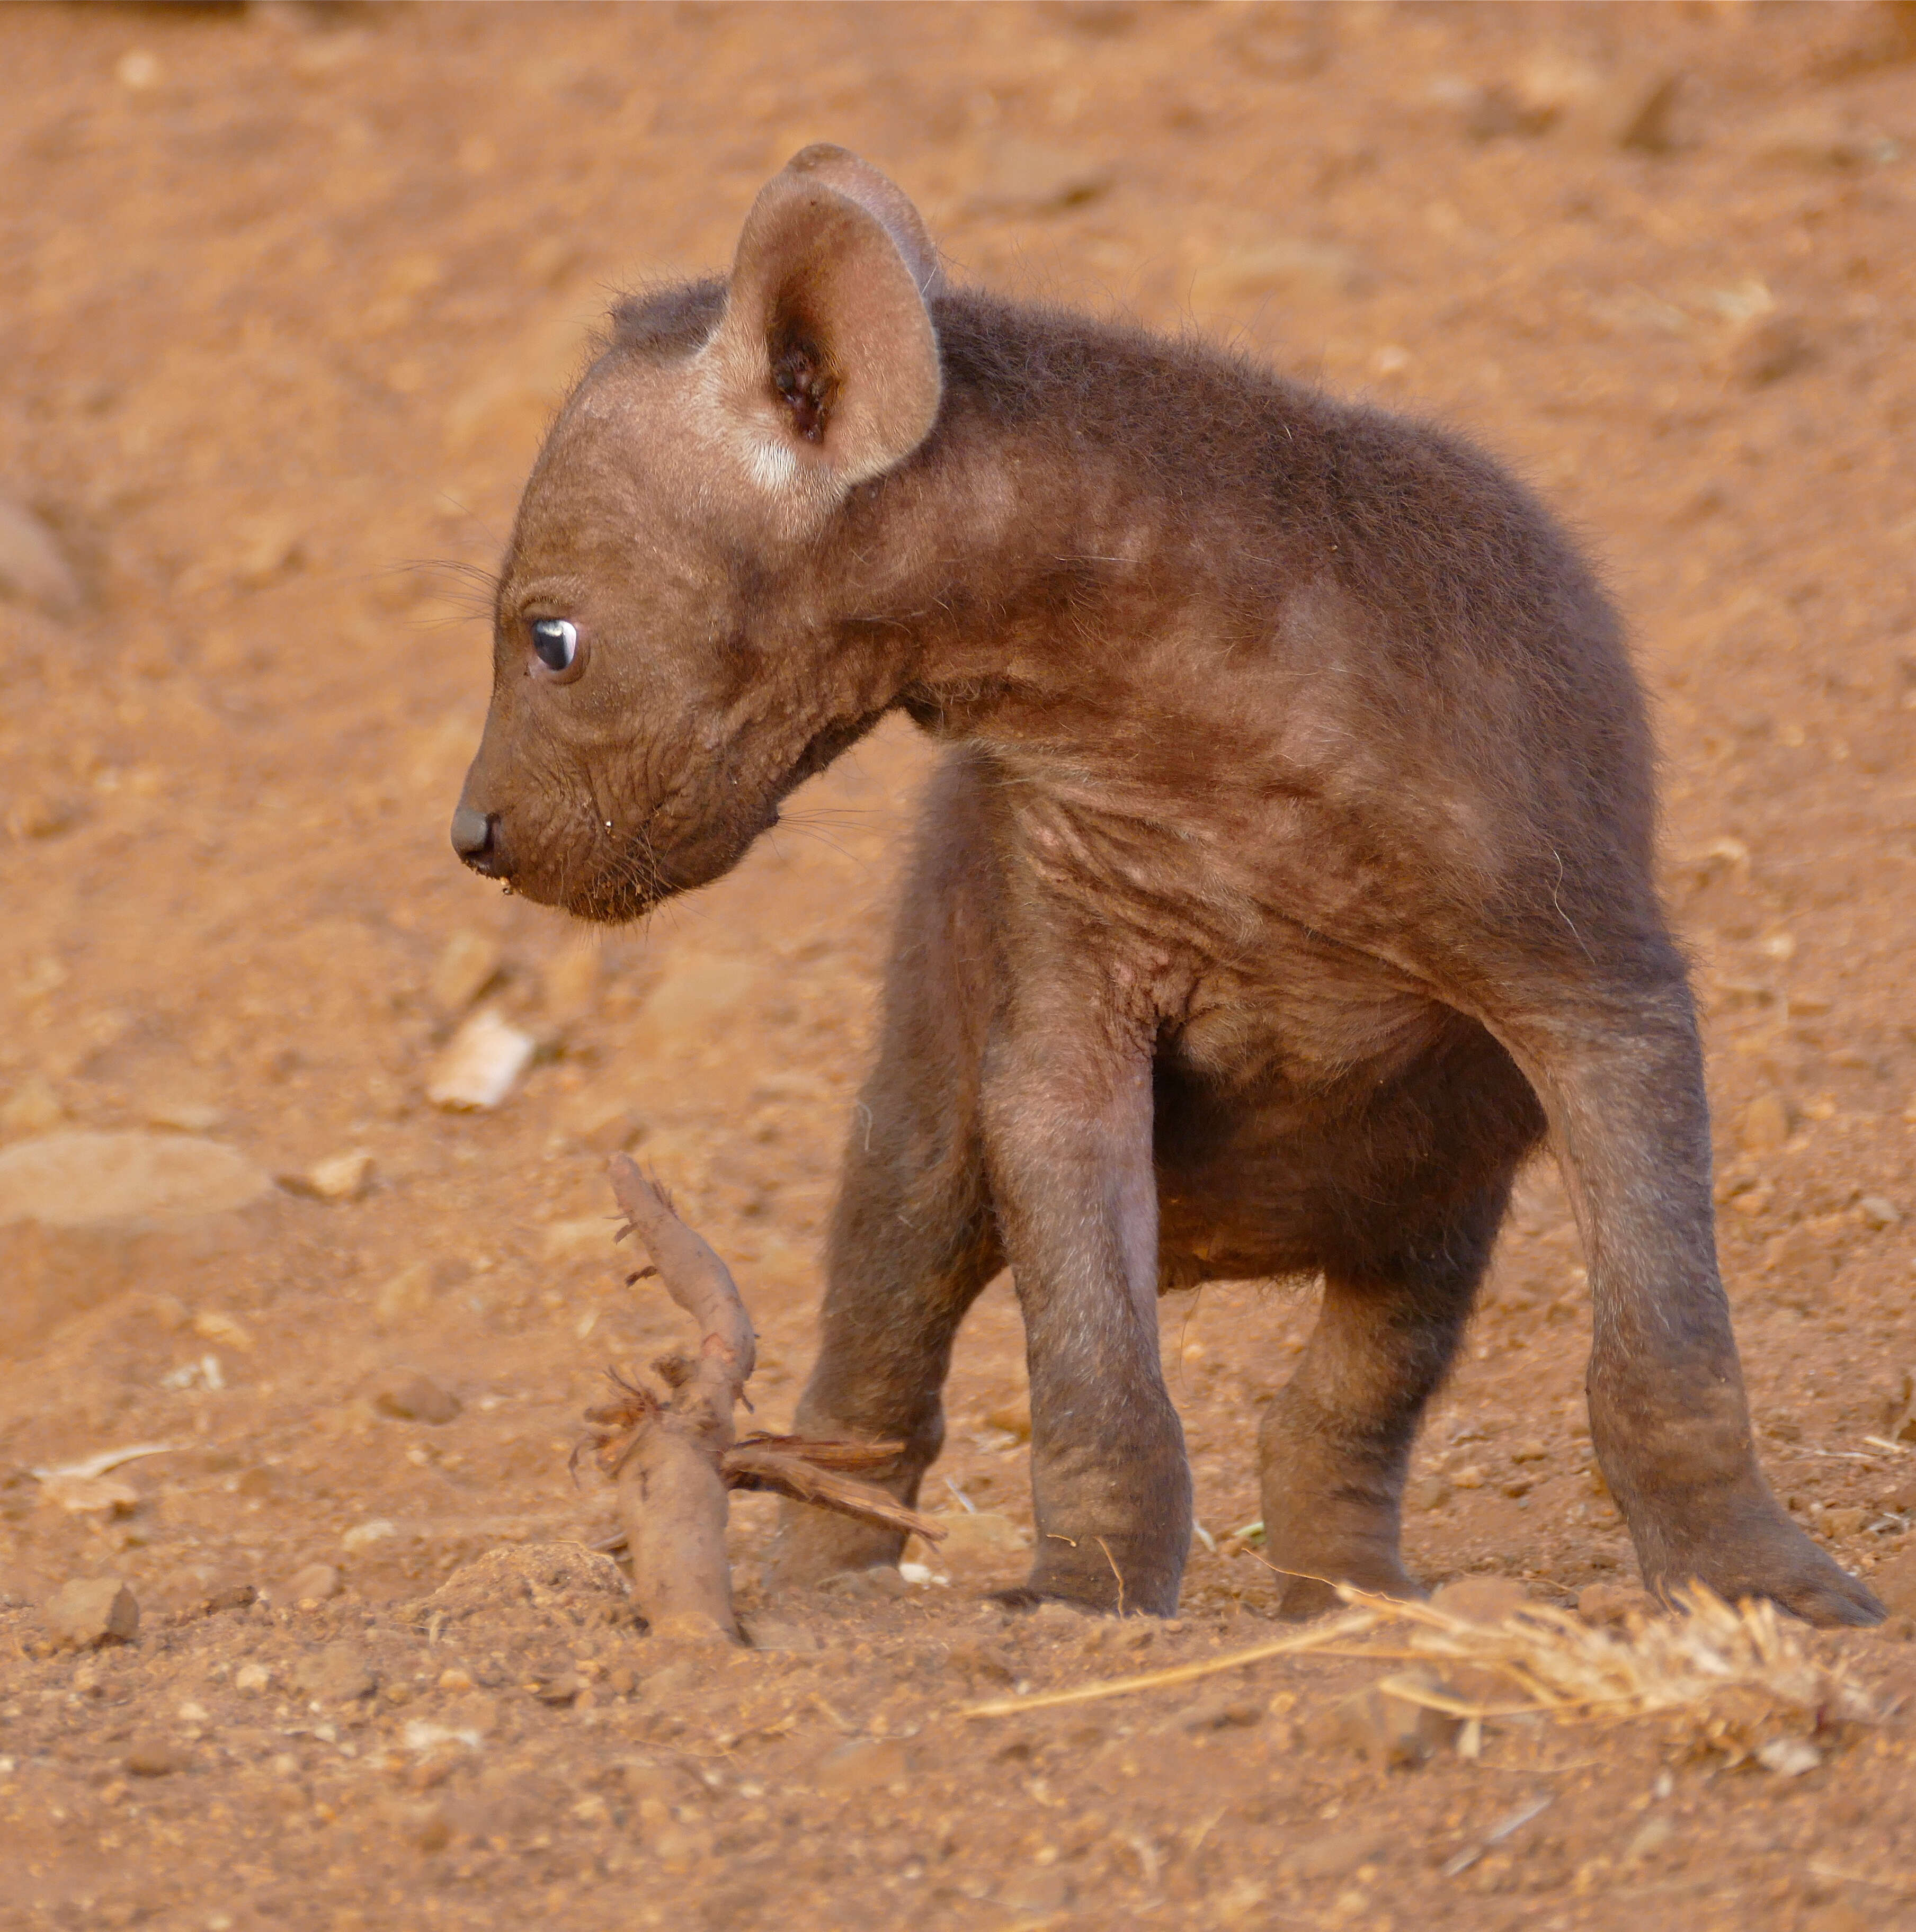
585,1153,944,1642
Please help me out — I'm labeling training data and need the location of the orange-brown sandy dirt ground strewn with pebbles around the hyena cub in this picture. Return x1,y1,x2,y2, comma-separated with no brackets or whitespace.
0,4,1916,1932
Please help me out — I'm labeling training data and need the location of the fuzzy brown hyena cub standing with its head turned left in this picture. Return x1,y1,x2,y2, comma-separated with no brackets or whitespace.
456,149,1881,1621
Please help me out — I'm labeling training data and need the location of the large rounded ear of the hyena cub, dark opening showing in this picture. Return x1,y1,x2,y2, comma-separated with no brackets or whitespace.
709,143,941,498
